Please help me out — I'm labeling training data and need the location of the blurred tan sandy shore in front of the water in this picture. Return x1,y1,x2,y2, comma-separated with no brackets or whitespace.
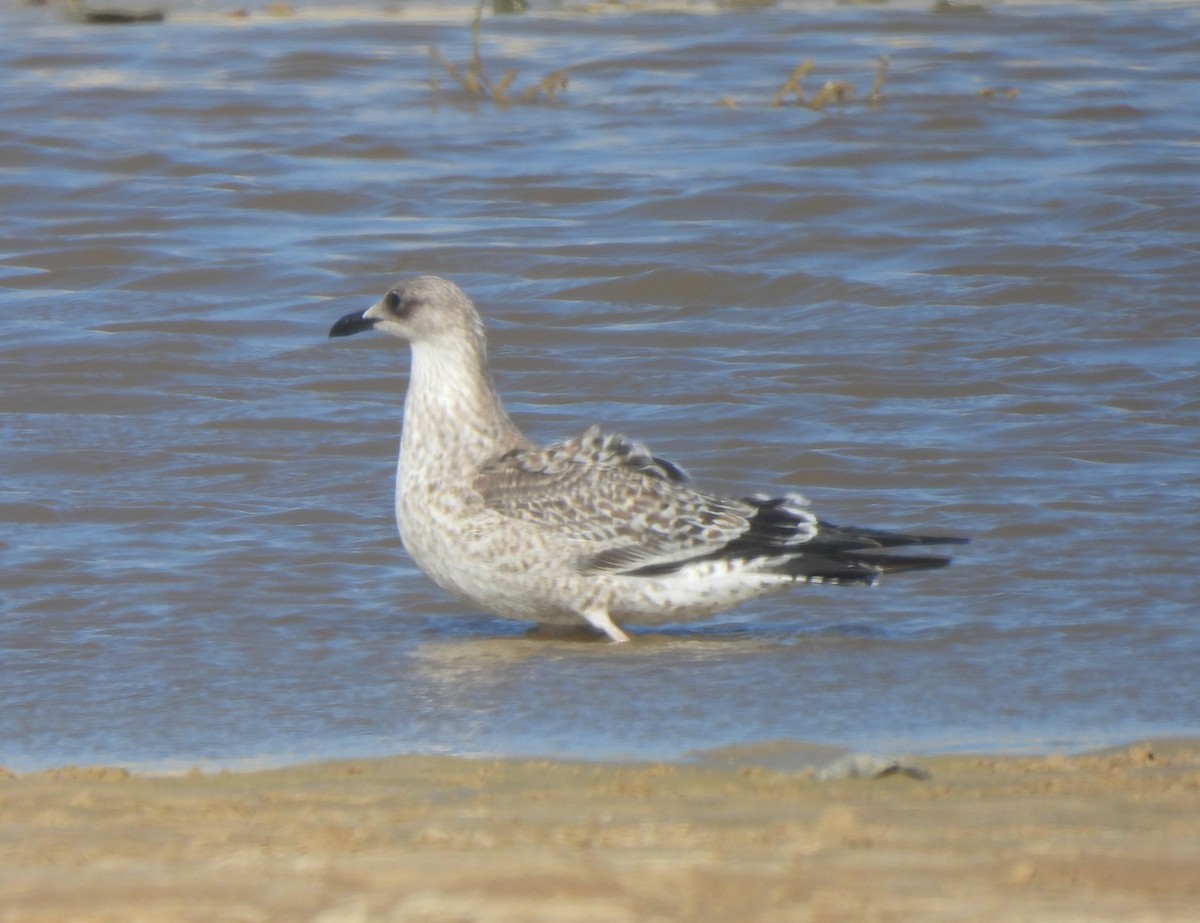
0,741,1200,923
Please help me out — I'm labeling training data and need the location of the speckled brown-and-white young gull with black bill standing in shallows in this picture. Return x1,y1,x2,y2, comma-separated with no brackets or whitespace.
329,276,965,642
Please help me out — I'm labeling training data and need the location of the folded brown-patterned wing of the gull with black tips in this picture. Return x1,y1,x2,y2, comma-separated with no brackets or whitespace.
474,427,960,583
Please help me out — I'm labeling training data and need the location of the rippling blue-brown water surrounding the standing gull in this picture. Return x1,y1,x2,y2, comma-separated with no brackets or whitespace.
0,1,1200,769
